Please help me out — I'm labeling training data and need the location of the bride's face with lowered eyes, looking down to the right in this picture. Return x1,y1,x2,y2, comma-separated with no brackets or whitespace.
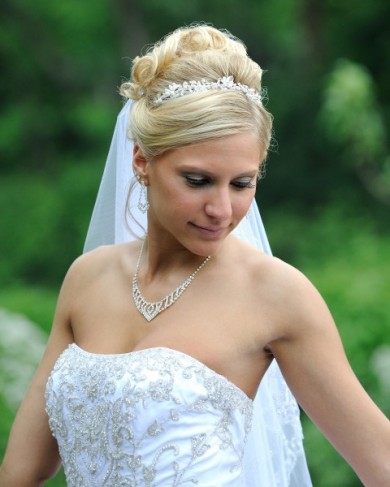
134,133,260,255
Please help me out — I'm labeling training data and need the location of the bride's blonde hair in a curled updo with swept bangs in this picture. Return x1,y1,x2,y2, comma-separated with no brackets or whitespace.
120,24,272,160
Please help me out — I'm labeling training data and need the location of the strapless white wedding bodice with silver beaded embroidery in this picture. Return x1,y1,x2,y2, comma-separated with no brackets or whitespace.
46,344,253,487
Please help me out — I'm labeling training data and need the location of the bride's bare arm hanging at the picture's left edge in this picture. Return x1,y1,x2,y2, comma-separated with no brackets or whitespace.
0,260,77,487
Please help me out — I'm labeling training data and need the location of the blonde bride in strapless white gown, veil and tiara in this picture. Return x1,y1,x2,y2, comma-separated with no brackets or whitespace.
0,25,390,487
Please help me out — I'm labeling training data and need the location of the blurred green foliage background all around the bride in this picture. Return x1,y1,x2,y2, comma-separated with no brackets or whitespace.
0,0,390,487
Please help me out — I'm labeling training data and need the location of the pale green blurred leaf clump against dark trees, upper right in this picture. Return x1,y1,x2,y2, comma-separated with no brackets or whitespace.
320,60,390,205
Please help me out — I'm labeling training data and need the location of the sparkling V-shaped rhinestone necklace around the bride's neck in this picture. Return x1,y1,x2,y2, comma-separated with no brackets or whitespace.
133,239,211,321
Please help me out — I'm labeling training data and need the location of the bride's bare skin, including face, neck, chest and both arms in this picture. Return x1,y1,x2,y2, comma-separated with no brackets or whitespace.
0,133,390,487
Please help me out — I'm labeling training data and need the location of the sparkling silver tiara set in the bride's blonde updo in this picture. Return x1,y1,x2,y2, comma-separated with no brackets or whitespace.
153,76,263,106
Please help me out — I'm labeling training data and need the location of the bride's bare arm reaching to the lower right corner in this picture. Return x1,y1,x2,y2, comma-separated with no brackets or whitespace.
270,269,390,487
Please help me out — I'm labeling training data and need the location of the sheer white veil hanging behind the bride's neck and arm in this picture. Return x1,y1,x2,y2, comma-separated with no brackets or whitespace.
84,101,312,487
